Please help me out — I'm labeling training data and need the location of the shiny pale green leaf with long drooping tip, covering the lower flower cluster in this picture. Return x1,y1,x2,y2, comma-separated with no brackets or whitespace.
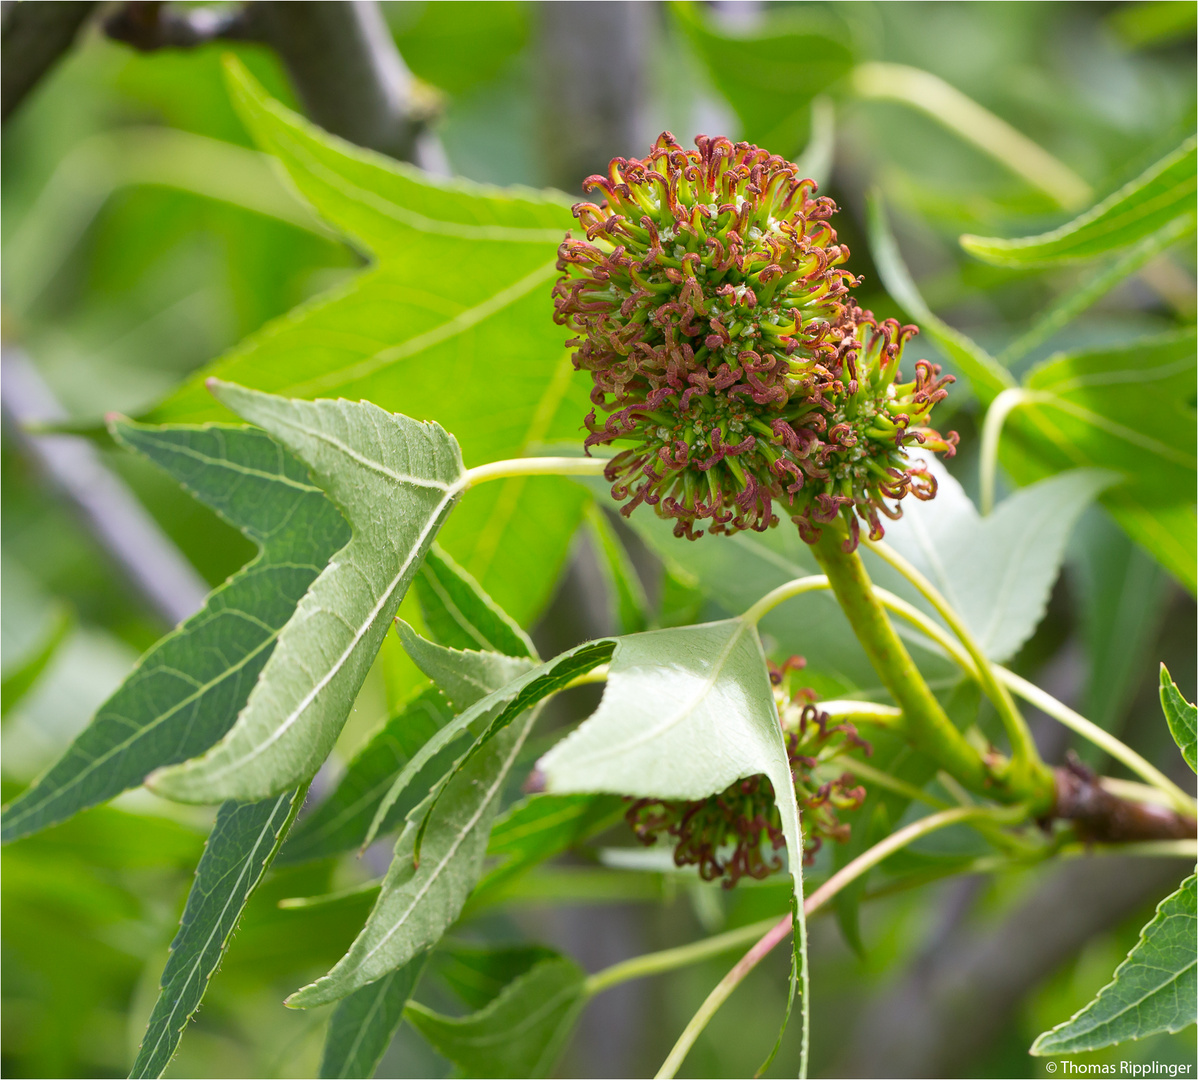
538,618,809,1074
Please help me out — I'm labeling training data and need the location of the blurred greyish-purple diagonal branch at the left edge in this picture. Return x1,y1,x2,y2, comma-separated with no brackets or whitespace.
0,345,208,626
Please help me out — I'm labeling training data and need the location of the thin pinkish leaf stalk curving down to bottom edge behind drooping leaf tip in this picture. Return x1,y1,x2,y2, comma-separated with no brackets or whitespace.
657,804,1027,1080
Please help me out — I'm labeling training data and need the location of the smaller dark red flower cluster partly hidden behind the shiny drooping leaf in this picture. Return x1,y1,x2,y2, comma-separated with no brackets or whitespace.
625,657,871,888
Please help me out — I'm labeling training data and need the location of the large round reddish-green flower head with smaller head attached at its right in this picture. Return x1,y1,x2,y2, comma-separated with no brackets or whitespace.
553,132,956,546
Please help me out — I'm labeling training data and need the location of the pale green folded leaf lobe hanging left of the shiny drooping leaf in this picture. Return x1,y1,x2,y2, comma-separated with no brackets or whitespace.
288,699,536,1008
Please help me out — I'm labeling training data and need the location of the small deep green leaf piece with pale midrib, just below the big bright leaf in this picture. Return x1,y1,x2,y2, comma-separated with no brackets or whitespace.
415,545,537,657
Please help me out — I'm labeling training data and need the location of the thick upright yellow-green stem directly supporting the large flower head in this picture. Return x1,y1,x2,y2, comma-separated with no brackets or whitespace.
809,528,996,797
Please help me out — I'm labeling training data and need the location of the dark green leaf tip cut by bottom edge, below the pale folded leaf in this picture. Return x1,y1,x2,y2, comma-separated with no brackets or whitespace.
320,954,428,1078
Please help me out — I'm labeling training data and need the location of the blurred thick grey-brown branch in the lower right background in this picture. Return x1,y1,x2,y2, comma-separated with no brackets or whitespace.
829,857,1185,1076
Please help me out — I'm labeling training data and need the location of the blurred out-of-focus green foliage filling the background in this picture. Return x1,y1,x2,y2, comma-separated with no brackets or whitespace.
0,0,1196,1076
